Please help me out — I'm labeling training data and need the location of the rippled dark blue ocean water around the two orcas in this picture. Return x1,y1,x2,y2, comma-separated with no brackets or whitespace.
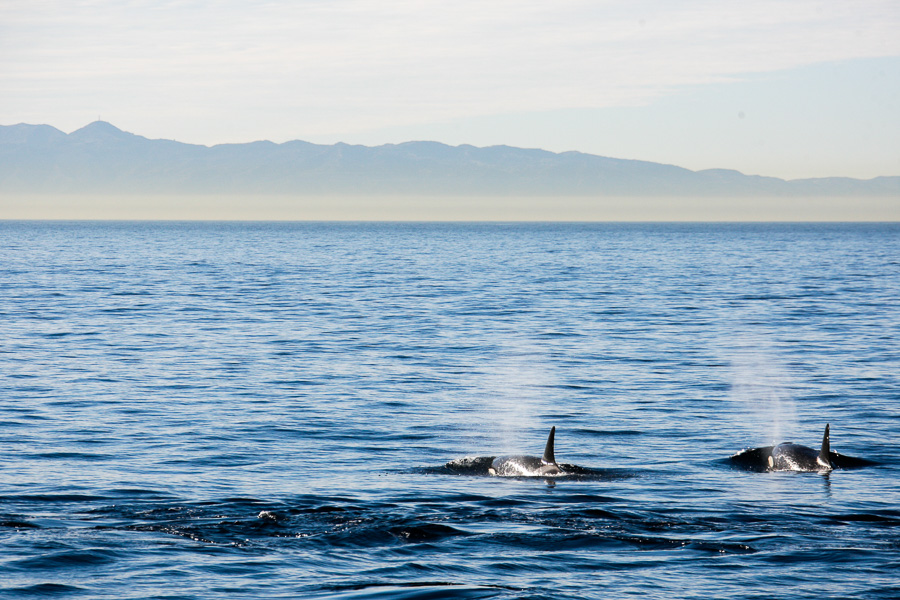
0,222,900,599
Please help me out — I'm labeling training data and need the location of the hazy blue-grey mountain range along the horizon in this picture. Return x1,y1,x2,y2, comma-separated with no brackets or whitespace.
0,121,900,197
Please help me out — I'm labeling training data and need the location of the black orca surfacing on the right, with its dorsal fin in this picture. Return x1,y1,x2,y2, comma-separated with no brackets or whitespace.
729,425,876,473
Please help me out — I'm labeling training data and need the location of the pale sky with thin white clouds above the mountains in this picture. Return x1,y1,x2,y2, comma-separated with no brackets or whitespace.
0,0,900,178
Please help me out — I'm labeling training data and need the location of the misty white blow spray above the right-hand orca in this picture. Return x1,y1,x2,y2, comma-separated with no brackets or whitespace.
726,337,796,444
